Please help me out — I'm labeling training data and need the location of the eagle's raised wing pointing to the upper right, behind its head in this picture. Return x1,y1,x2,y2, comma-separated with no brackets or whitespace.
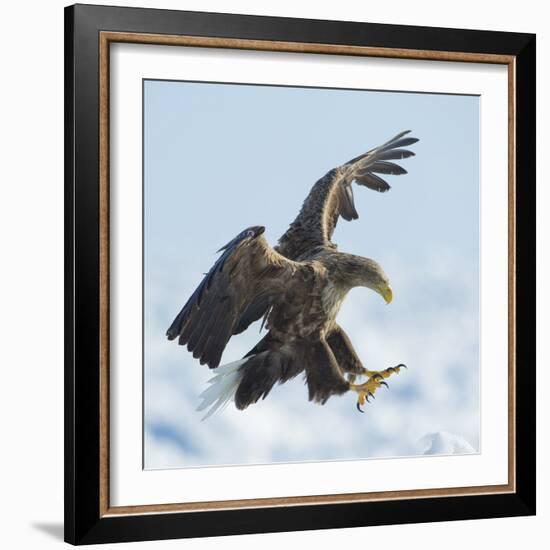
276,130,418,260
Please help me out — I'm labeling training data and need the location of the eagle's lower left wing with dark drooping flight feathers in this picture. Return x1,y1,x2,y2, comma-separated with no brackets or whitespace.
166,227,308,368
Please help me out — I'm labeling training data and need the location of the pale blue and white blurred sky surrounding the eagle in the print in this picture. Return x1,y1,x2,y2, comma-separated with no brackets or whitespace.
144,80,480,469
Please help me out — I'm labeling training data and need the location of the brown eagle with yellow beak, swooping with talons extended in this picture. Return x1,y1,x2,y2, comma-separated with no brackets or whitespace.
166,130,418,418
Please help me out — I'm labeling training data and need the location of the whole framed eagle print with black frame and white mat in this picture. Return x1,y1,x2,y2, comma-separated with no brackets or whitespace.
65,5,535,544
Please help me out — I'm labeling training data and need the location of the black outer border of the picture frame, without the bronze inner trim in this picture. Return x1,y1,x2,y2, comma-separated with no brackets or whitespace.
65,4,536,544
